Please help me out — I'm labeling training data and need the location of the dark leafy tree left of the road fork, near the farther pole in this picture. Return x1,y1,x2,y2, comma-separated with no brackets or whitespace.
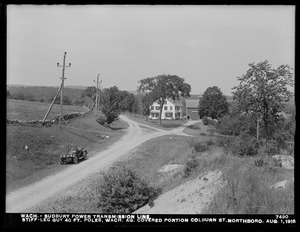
101,86,122,125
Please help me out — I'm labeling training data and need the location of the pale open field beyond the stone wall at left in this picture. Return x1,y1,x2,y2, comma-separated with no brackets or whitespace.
6,99,85,120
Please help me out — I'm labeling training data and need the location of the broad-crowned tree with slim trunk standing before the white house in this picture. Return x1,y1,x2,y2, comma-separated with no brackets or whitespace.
138,74,191,125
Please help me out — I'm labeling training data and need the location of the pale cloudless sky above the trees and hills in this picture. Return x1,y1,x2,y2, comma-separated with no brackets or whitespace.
7,5,295,95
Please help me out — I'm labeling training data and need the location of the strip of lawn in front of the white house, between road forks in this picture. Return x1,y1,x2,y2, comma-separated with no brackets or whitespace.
124,113,186,130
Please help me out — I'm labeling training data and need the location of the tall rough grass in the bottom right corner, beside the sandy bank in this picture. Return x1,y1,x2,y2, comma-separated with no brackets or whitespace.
203,154,294,214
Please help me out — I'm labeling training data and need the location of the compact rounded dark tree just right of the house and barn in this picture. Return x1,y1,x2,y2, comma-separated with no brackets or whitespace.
198,86,228,119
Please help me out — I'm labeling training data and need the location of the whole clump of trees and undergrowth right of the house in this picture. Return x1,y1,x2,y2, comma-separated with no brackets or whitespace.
198,60,295,145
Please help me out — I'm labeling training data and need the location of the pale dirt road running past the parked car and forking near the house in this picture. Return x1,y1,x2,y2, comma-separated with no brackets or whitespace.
6,116,197,213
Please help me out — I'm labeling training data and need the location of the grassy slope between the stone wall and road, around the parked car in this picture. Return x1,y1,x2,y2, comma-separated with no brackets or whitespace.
6,101,128,192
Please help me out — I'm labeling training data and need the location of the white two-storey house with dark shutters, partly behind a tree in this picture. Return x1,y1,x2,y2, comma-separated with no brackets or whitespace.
149,99,182,119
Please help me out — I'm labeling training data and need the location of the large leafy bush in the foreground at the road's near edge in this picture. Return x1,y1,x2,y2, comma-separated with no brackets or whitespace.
98,167,161,214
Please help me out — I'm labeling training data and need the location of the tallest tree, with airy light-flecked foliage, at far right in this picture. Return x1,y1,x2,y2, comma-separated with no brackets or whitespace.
233,60,294,140
